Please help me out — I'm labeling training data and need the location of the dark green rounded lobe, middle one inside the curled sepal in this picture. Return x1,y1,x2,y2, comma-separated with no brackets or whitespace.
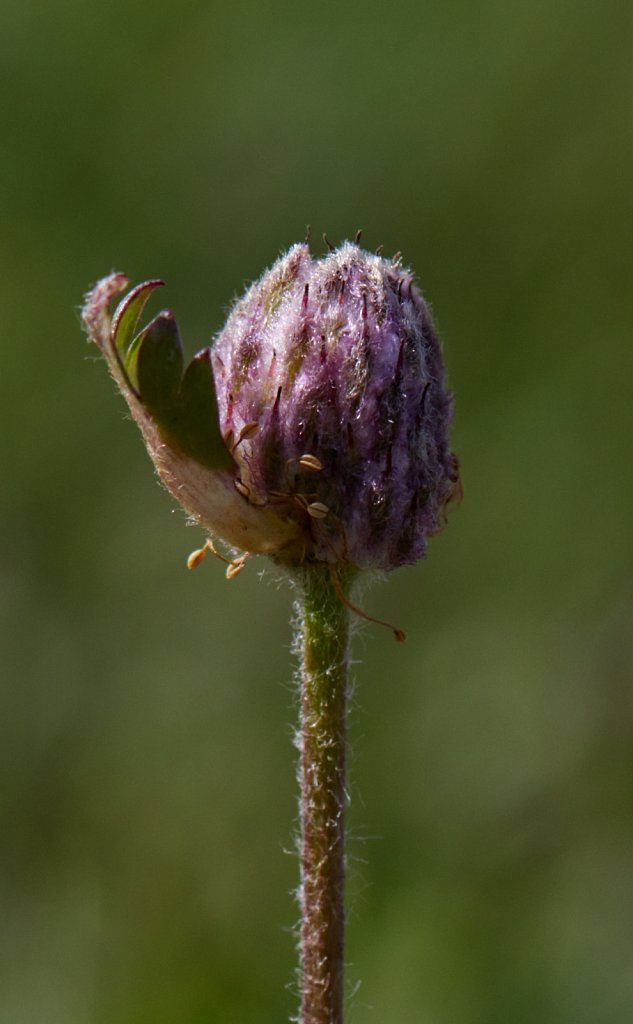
124,310,184,414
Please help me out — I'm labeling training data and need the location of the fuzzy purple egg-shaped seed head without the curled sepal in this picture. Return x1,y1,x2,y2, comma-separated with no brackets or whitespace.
212,243,458,569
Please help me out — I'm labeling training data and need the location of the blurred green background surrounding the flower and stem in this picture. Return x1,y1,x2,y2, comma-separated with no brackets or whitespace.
0,0,633,1024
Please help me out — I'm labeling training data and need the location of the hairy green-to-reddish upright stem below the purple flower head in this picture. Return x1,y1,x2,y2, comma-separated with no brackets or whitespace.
298,564,349,1024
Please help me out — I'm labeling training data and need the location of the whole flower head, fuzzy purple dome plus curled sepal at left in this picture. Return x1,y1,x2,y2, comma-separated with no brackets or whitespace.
84,244,458,569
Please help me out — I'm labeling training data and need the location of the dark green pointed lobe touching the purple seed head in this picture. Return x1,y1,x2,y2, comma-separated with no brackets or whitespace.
159,348,235,471
